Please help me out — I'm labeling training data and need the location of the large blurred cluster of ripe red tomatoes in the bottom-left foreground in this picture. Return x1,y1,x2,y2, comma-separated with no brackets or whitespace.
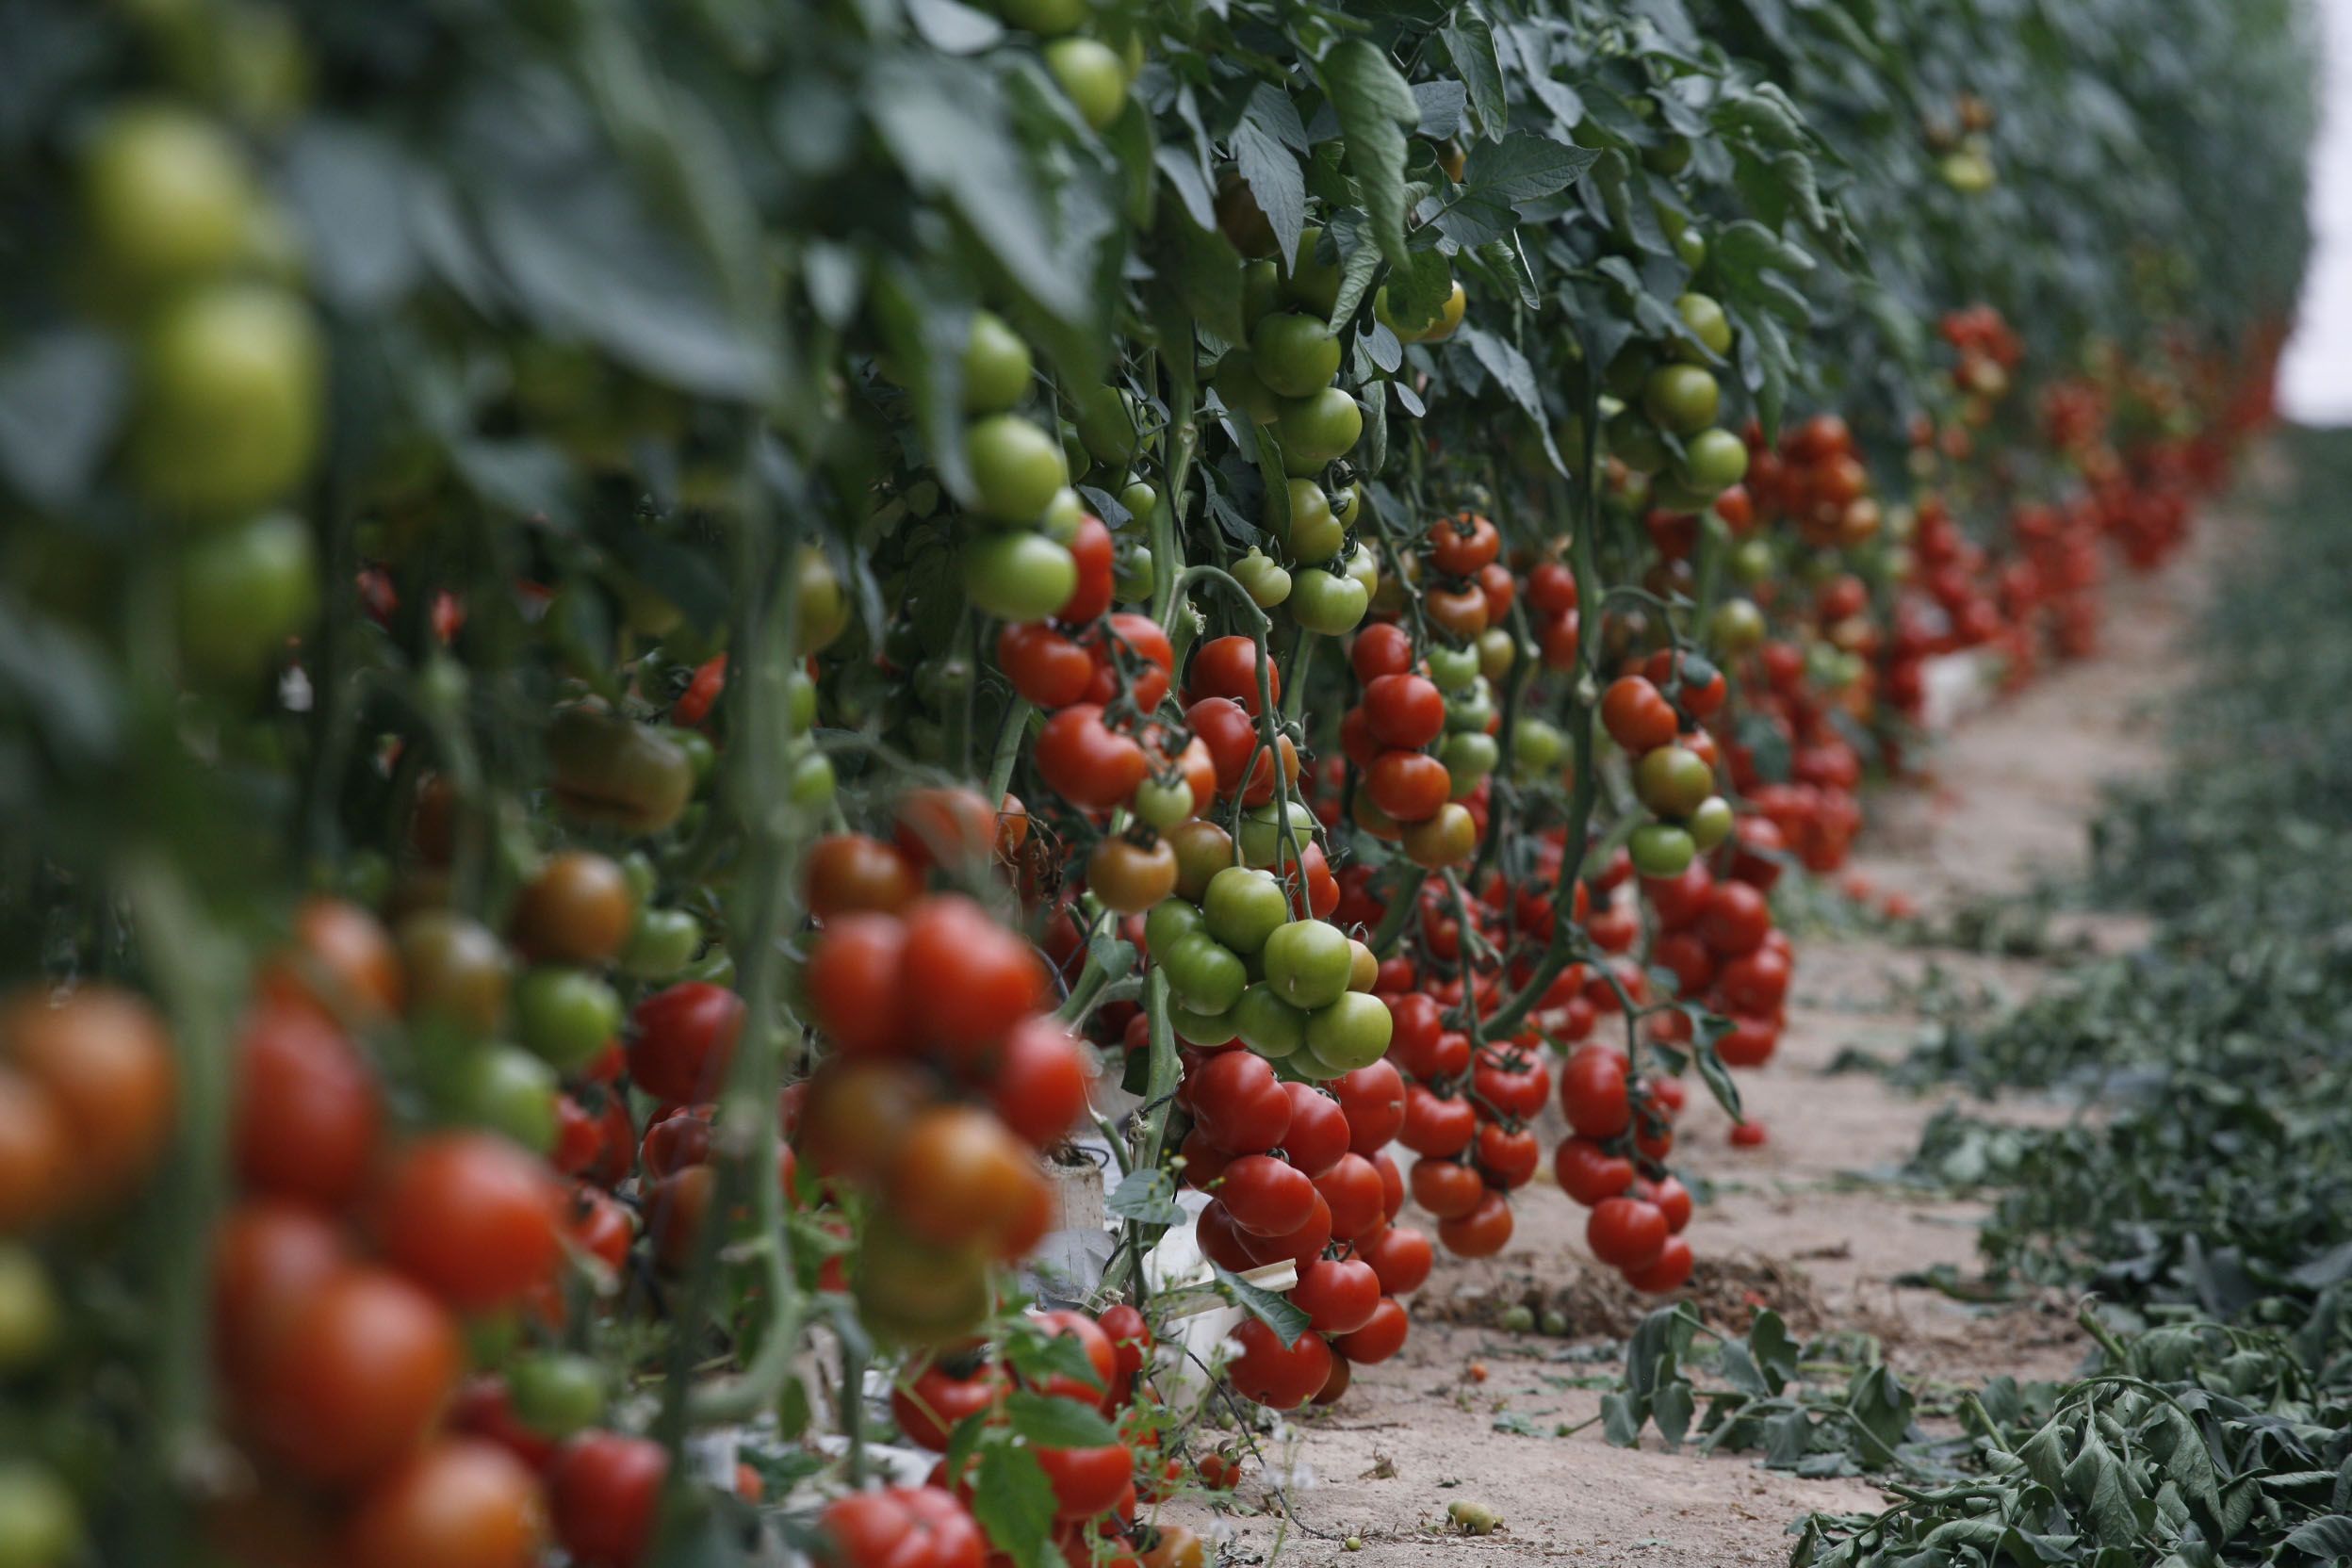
214,900,596,1568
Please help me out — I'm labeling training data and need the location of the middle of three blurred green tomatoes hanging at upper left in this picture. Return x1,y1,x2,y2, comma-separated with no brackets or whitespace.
132,285,327,517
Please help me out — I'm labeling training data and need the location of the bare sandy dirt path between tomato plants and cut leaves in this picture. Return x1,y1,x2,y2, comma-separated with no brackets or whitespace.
1187,516,2228,1568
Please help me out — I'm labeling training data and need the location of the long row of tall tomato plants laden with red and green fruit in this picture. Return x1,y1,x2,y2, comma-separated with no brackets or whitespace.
0,0,2298,1568
